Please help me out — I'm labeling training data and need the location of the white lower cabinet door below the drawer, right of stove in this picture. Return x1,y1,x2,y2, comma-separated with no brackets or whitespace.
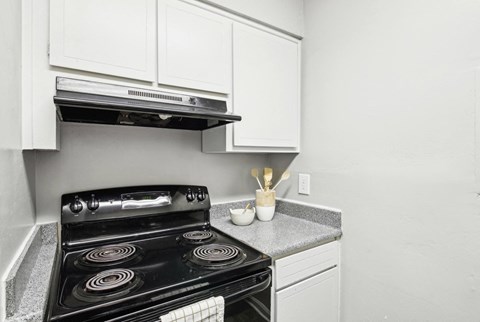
275,267,339,322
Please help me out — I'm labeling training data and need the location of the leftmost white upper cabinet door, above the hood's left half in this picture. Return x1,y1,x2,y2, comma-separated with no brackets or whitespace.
50,0,156,82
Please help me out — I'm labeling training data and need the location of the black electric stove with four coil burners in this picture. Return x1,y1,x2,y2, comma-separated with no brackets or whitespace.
48,185,271,321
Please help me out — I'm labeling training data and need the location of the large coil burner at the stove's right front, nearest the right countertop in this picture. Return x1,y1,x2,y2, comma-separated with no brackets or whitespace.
187,244,247,269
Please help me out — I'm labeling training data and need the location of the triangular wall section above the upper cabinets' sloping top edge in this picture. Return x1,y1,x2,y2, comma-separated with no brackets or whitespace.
199,0,303,36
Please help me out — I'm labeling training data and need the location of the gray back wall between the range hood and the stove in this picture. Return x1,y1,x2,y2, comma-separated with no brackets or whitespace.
36,123,267,222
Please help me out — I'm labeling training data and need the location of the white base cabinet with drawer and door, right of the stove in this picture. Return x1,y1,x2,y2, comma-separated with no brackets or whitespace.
274,241,339,322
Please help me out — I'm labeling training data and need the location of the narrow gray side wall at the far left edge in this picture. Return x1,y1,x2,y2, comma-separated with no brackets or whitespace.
0,0,35,314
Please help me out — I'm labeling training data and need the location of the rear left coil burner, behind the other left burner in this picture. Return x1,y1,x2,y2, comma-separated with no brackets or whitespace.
76,244,140,267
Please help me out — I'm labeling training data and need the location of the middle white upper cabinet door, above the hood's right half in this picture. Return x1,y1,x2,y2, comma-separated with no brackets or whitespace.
158,0,232,93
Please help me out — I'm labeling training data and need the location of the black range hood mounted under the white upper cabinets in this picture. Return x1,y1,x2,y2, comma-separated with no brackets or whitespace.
53,77,242,131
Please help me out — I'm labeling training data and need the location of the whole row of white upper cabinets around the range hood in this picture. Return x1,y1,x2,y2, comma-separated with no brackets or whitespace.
45,0,301,153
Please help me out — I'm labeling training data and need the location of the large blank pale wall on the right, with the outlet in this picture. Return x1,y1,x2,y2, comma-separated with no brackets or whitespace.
271,0,480,321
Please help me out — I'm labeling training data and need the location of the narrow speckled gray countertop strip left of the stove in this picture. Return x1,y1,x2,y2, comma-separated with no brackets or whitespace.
5,223,58,322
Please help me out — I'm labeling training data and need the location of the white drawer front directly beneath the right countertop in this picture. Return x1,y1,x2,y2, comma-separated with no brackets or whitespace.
275,241,339,290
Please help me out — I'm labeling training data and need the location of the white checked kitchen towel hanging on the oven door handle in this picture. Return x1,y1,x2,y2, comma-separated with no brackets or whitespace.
160,296,225,322
